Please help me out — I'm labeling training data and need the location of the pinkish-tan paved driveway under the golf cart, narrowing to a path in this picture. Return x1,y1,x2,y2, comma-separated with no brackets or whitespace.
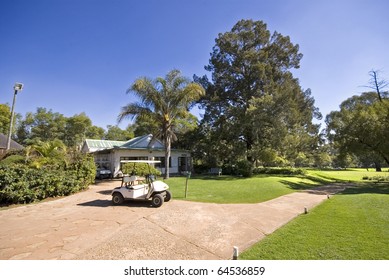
0,181,336,260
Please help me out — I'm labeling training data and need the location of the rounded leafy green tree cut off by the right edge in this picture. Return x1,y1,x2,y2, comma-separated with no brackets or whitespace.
326,92,389,170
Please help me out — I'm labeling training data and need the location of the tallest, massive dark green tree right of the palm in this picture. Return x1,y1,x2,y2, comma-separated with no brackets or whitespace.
195,20,321,168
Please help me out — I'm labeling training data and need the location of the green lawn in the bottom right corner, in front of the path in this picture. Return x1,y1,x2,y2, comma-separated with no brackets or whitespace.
240,183,389,260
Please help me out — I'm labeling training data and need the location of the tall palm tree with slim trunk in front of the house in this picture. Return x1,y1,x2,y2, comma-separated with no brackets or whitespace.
118,70,205,179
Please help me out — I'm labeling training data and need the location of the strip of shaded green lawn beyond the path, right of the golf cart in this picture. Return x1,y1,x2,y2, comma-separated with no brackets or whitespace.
166,169,387,203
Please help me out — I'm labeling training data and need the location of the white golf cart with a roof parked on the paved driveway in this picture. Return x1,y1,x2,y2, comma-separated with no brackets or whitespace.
112,160,172,207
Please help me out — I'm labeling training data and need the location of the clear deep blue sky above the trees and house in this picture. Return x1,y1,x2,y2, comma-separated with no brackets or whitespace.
0,0,389,128
